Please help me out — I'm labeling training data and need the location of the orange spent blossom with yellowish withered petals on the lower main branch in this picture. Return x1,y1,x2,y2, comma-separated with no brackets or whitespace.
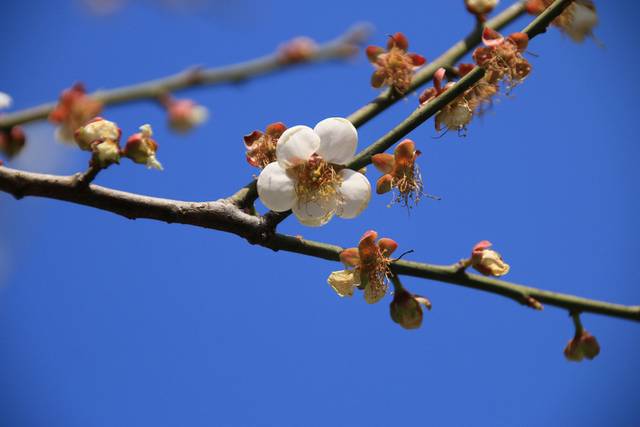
327,230,398,304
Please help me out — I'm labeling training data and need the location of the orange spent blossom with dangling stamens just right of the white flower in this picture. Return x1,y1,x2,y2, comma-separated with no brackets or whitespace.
371,139,422,206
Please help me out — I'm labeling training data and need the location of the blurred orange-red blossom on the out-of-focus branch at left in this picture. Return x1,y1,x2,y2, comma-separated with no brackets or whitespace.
49,83,103,142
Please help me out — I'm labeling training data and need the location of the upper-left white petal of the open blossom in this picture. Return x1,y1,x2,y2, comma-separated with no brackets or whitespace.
276,126,320,169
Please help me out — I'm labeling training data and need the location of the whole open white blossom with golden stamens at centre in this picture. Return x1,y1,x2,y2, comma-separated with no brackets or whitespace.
258,117,371,227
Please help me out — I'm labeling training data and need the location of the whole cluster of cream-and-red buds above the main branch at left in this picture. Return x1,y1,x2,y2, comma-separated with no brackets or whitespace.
74,117,162,170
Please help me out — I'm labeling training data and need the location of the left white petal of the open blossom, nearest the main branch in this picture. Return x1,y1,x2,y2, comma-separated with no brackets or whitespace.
258,162,296,212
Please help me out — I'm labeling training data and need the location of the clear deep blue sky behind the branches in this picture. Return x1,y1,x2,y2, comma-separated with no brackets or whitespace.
0,0,640,427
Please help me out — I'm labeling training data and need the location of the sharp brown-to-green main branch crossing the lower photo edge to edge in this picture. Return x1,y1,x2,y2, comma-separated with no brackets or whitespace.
0,166,640,321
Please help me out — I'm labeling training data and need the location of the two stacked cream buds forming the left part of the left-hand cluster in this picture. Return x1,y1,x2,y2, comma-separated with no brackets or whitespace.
74,117,122,168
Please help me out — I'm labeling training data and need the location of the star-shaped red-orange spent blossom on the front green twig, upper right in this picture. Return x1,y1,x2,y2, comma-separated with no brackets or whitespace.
473,27,531,92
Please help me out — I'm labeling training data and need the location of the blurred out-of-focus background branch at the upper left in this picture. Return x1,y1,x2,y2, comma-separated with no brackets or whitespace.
0,25,370,129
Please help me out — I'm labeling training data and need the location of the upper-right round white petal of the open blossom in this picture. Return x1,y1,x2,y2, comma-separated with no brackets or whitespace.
313,117,358,165
